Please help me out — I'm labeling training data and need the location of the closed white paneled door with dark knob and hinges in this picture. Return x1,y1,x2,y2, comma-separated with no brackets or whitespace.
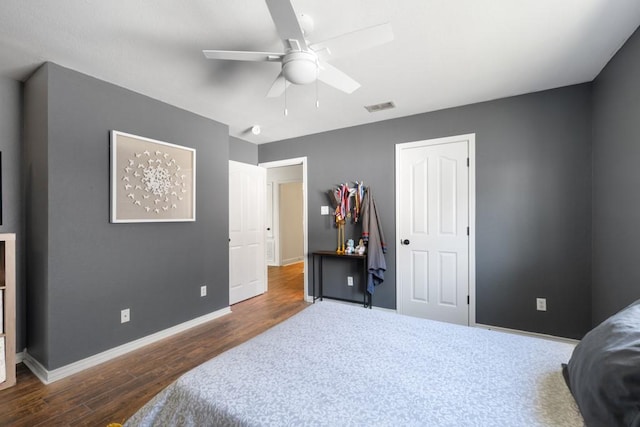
396,135,473,325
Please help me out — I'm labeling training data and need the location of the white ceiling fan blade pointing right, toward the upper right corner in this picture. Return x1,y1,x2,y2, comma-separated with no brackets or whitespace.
309,22,393,58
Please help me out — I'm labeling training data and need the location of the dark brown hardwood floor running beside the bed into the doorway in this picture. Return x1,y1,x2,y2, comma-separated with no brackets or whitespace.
0,263,307,426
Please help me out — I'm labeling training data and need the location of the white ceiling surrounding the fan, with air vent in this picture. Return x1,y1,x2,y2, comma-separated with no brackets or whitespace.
0,0,640,143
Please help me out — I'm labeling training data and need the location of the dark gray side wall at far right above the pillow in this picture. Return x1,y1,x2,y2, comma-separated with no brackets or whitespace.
593,26,640,325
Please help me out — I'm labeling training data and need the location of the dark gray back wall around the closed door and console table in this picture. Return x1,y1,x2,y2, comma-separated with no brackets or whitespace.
258,84,591,338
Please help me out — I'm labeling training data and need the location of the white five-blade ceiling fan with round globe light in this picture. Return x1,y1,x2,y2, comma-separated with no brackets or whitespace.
202,0,393,97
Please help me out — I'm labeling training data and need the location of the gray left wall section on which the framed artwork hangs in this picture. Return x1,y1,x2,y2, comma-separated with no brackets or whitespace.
25,64,229,369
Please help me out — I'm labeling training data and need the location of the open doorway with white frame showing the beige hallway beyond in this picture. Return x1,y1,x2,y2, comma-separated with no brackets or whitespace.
258,157,312,302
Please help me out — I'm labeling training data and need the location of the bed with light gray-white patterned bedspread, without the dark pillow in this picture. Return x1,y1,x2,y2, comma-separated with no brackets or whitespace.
125,301,583,427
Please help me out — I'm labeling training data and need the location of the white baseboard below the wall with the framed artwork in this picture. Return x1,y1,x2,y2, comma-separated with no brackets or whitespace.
22,307,231,384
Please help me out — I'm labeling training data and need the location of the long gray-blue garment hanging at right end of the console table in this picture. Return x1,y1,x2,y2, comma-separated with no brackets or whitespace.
362,188,387,294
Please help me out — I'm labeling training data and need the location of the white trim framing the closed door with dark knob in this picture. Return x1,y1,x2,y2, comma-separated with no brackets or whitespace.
395,133,476,326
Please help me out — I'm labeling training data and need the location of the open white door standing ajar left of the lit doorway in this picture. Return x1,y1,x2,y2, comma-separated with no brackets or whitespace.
229,161,267,305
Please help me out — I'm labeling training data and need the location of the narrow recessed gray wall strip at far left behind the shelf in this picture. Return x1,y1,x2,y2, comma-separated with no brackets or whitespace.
0,78,26,351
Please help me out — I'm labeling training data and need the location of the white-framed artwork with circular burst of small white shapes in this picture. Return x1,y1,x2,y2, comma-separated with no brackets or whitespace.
110,130,196,223
